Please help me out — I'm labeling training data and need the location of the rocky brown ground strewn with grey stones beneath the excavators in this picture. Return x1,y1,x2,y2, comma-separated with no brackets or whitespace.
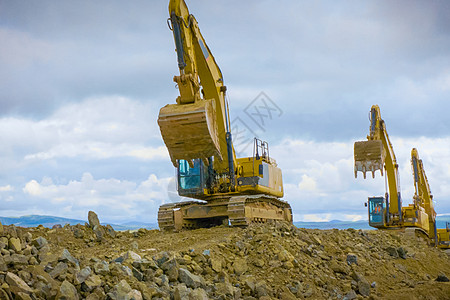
0,212,450,300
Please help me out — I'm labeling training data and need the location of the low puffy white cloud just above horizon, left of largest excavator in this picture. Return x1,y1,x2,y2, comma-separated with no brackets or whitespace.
16,173,181,222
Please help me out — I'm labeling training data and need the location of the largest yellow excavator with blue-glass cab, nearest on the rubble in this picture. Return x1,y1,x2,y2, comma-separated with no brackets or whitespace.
158,0,292,230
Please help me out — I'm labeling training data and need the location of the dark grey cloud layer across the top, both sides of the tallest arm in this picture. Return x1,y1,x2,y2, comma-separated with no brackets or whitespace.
0,1,450,121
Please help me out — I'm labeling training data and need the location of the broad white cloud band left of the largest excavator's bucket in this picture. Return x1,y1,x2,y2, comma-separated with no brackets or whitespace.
0,96,167,164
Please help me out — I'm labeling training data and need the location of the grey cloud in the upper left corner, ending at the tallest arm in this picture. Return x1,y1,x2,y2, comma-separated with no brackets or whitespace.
0,1,176,118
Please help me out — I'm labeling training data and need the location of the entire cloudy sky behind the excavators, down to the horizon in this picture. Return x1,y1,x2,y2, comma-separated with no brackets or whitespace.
0,0,450,223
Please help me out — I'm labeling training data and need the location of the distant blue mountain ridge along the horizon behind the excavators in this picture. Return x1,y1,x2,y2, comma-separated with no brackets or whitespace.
0,215,450,230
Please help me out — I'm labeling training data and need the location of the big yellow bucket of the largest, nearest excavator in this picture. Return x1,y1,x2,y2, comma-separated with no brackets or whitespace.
158,100,222,167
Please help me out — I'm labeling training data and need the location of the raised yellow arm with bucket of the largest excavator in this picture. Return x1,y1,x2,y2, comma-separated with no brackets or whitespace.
158,0,236,177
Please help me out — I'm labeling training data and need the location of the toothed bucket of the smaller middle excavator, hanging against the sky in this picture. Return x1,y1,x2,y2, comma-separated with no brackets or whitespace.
354,140,385,178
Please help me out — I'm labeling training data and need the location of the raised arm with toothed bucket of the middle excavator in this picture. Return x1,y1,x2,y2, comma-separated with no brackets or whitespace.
354,105,402,224
